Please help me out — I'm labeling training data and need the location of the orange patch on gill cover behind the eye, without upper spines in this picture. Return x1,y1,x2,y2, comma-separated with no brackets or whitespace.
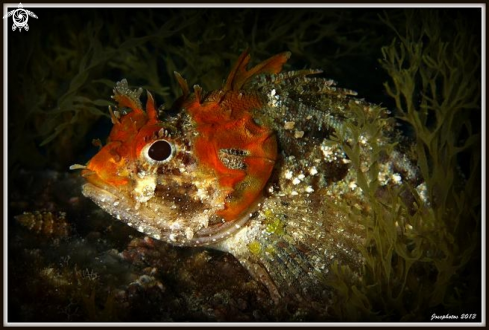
186,92,277,221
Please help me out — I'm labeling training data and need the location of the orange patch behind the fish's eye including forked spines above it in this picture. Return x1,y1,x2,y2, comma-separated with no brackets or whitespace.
184,51,290,221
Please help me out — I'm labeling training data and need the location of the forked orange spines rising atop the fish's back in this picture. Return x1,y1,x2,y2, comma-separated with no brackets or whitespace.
223,50,290,91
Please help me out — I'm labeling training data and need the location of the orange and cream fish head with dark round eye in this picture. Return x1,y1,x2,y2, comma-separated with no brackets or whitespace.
77,52,289,246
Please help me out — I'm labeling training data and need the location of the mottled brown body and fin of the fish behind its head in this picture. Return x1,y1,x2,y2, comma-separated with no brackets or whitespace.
217,70,417,304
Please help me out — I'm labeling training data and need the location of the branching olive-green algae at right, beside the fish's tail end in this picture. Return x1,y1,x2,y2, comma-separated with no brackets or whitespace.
333,10,481,321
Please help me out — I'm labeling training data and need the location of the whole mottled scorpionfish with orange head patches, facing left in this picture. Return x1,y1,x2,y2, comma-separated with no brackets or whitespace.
74,51,419,305
